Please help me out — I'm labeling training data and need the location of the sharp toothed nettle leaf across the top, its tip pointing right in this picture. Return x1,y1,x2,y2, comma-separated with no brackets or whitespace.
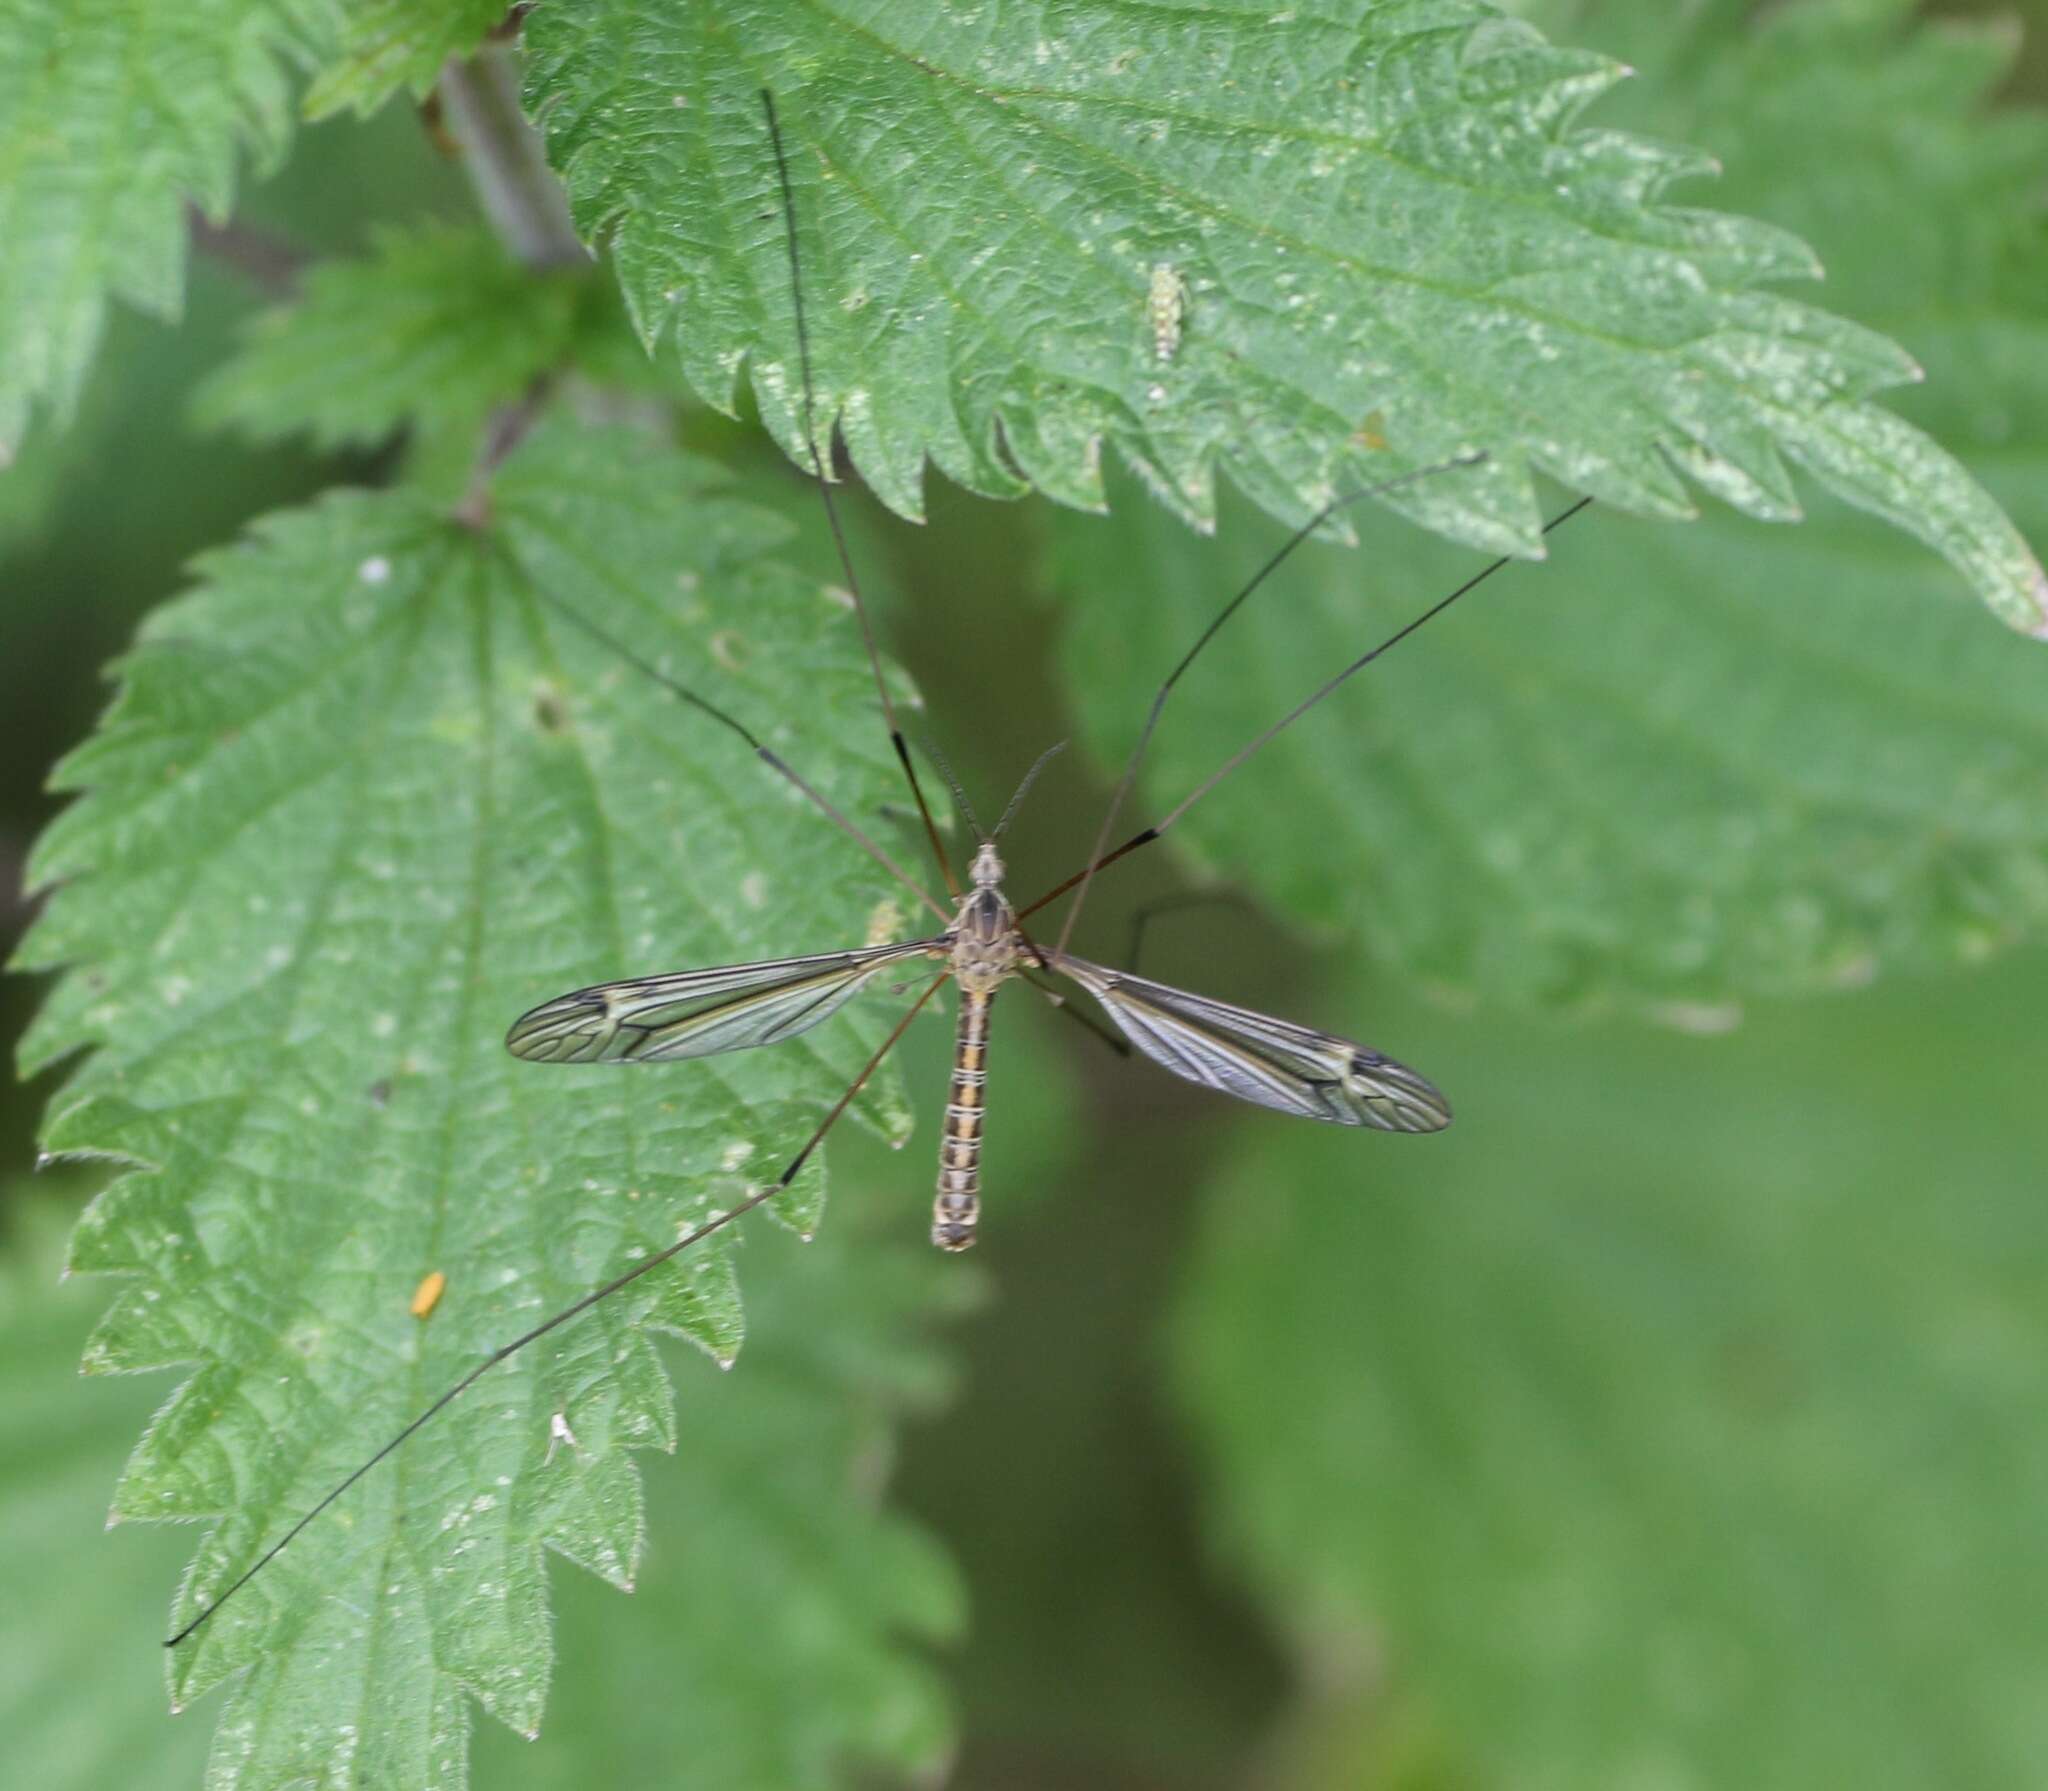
526,0,2048,630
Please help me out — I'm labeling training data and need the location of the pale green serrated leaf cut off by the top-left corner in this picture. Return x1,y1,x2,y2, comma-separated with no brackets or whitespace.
0,0,332,454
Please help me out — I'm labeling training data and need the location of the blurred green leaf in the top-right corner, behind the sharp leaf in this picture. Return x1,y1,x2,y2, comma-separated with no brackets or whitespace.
1540,0,2048,497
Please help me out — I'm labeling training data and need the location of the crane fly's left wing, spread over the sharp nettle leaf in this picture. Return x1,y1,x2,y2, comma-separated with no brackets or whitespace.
506,940,946,1064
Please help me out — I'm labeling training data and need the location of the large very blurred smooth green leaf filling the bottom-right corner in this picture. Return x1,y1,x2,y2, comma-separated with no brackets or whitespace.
1178,956,2048,1791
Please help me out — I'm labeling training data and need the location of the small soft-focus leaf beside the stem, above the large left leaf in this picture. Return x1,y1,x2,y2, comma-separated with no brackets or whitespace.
195,223,608,448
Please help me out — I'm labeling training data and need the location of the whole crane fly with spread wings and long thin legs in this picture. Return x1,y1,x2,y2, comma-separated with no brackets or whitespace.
164,90,1591,1648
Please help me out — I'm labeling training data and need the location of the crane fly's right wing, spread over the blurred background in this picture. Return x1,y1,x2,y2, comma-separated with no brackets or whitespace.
1053,956,1450,1132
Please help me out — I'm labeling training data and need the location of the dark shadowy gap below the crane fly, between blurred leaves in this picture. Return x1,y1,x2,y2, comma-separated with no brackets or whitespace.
884,986,1288,1791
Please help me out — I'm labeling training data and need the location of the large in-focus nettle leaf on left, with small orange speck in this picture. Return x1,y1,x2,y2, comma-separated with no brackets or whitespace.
23,417,946,1787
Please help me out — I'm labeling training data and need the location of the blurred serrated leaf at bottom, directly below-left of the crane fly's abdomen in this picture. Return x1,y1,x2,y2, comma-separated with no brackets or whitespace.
477,1203,967,1791
